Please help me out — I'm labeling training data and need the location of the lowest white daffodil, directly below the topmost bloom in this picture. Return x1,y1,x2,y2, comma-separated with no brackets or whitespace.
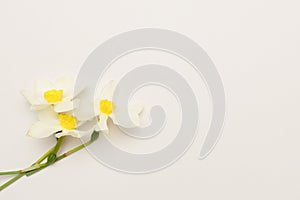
27,108,91,138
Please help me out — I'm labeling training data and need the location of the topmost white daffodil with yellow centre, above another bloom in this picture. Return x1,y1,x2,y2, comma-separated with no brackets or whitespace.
21,76,78,113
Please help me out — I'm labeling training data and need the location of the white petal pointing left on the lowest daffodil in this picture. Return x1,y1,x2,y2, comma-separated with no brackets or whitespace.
27,121,61,138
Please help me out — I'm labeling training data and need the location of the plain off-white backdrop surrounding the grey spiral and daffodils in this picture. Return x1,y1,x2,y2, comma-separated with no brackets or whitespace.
0,0,300,200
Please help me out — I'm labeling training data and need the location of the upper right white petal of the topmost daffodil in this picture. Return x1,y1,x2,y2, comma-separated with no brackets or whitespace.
54,76,74,97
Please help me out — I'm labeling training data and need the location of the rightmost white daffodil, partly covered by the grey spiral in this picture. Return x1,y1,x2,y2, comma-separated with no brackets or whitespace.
94,81,143,133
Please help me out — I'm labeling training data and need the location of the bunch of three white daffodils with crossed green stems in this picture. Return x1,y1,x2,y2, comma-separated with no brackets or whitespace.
0,76,142,191
